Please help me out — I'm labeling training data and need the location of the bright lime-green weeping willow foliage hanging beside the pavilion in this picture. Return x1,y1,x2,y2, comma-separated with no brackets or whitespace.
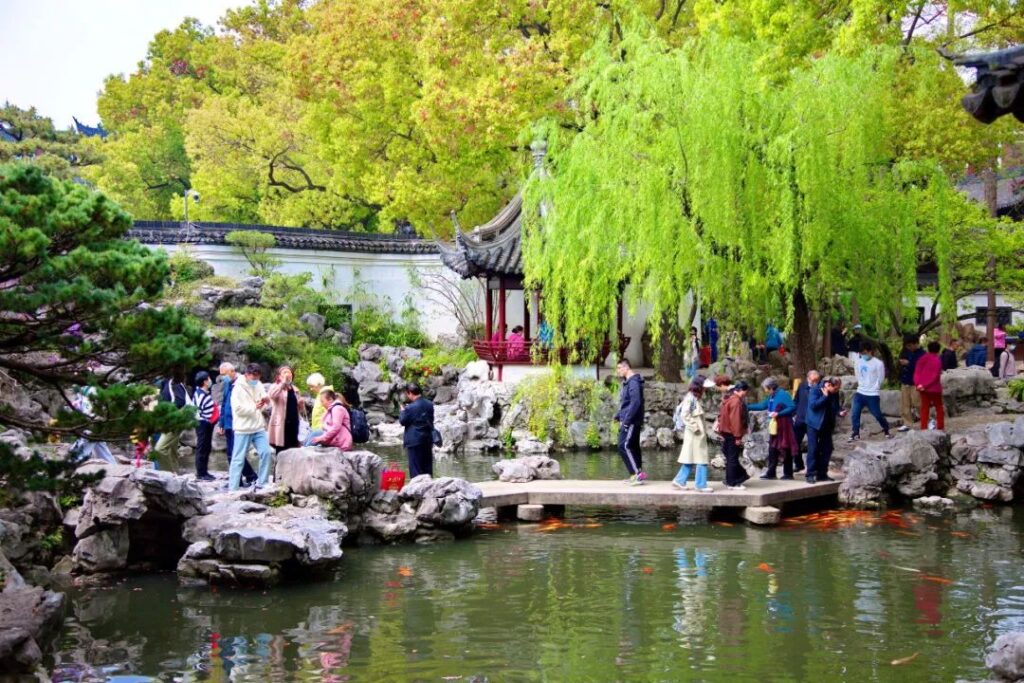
524,31,957,372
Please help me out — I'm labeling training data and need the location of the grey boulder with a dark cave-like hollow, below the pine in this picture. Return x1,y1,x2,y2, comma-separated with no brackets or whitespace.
73,465,206,572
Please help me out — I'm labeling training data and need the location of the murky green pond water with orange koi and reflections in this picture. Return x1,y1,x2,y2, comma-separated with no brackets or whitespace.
50,454,1024,683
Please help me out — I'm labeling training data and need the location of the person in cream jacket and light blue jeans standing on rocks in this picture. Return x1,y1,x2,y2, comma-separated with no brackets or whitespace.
228,362,273,490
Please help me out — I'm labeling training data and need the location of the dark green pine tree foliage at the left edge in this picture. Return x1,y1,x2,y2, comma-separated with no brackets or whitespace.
0,164,208,440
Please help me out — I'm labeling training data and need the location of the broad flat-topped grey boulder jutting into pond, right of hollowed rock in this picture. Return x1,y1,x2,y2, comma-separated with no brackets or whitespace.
177,494,348,585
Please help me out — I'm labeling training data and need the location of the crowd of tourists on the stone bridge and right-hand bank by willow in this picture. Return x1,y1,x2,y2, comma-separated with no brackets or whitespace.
615,321,1016,493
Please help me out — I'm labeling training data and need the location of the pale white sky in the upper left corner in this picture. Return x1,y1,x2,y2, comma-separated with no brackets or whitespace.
0,0,240,128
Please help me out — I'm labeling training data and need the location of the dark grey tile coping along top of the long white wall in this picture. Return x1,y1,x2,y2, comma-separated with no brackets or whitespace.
128,220,438,254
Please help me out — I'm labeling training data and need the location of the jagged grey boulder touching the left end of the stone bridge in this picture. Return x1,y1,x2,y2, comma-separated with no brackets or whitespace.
362,474,483,543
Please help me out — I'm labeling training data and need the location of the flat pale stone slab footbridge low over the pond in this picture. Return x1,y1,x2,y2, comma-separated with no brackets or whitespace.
476,479,840,508
